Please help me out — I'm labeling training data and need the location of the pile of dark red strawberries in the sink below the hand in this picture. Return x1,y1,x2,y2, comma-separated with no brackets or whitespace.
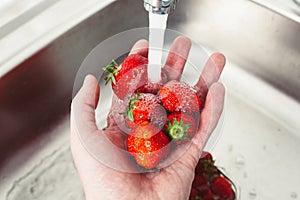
189,152,236,200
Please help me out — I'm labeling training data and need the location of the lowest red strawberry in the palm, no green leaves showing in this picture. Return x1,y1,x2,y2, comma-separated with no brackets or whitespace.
127,122,170,169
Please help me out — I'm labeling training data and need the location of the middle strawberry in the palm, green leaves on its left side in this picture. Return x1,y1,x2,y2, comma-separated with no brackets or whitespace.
126,93,166,128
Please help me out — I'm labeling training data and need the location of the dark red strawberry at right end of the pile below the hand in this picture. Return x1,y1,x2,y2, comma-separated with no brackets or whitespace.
210,176,233,198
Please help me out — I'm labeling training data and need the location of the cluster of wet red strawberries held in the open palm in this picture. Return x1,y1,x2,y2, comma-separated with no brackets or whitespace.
104,54,203,169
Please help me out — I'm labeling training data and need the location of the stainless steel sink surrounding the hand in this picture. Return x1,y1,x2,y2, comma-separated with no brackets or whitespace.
0,0,300,200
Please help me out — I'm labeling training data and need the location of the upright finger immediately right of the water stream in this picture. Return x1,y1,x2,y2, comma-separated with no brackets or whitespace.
163,36,192,80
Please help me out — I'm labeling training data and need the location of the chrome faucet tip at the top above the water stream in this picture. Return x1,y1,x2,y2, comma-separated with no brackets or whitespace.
144,0,179,14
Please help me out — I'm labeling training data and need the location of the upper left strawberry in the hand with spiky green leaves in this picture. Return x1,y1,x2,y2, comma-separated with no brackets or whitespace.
103,54,148,100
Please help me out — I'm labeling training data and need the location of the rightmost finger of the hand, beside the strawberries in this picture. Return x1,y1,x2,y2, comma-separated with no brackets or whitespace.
173,83,225,168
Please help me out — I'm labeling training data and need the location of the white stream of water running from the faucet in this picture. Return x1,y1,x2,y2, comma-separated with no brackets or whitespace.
148,12,168,83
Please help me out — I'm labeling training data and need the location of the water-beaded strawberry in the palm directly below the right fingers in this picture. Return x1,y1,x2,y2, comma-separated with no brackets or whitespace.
159,80,203,112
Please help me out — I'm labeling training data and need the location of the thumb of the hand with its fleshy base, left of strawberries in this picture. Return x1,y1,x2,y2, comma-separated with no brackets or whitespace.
71,75,135,172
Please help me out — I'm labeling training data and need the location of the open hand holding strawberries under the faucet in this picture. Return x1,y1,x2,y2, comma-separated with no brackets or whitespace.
70,37,225,200
